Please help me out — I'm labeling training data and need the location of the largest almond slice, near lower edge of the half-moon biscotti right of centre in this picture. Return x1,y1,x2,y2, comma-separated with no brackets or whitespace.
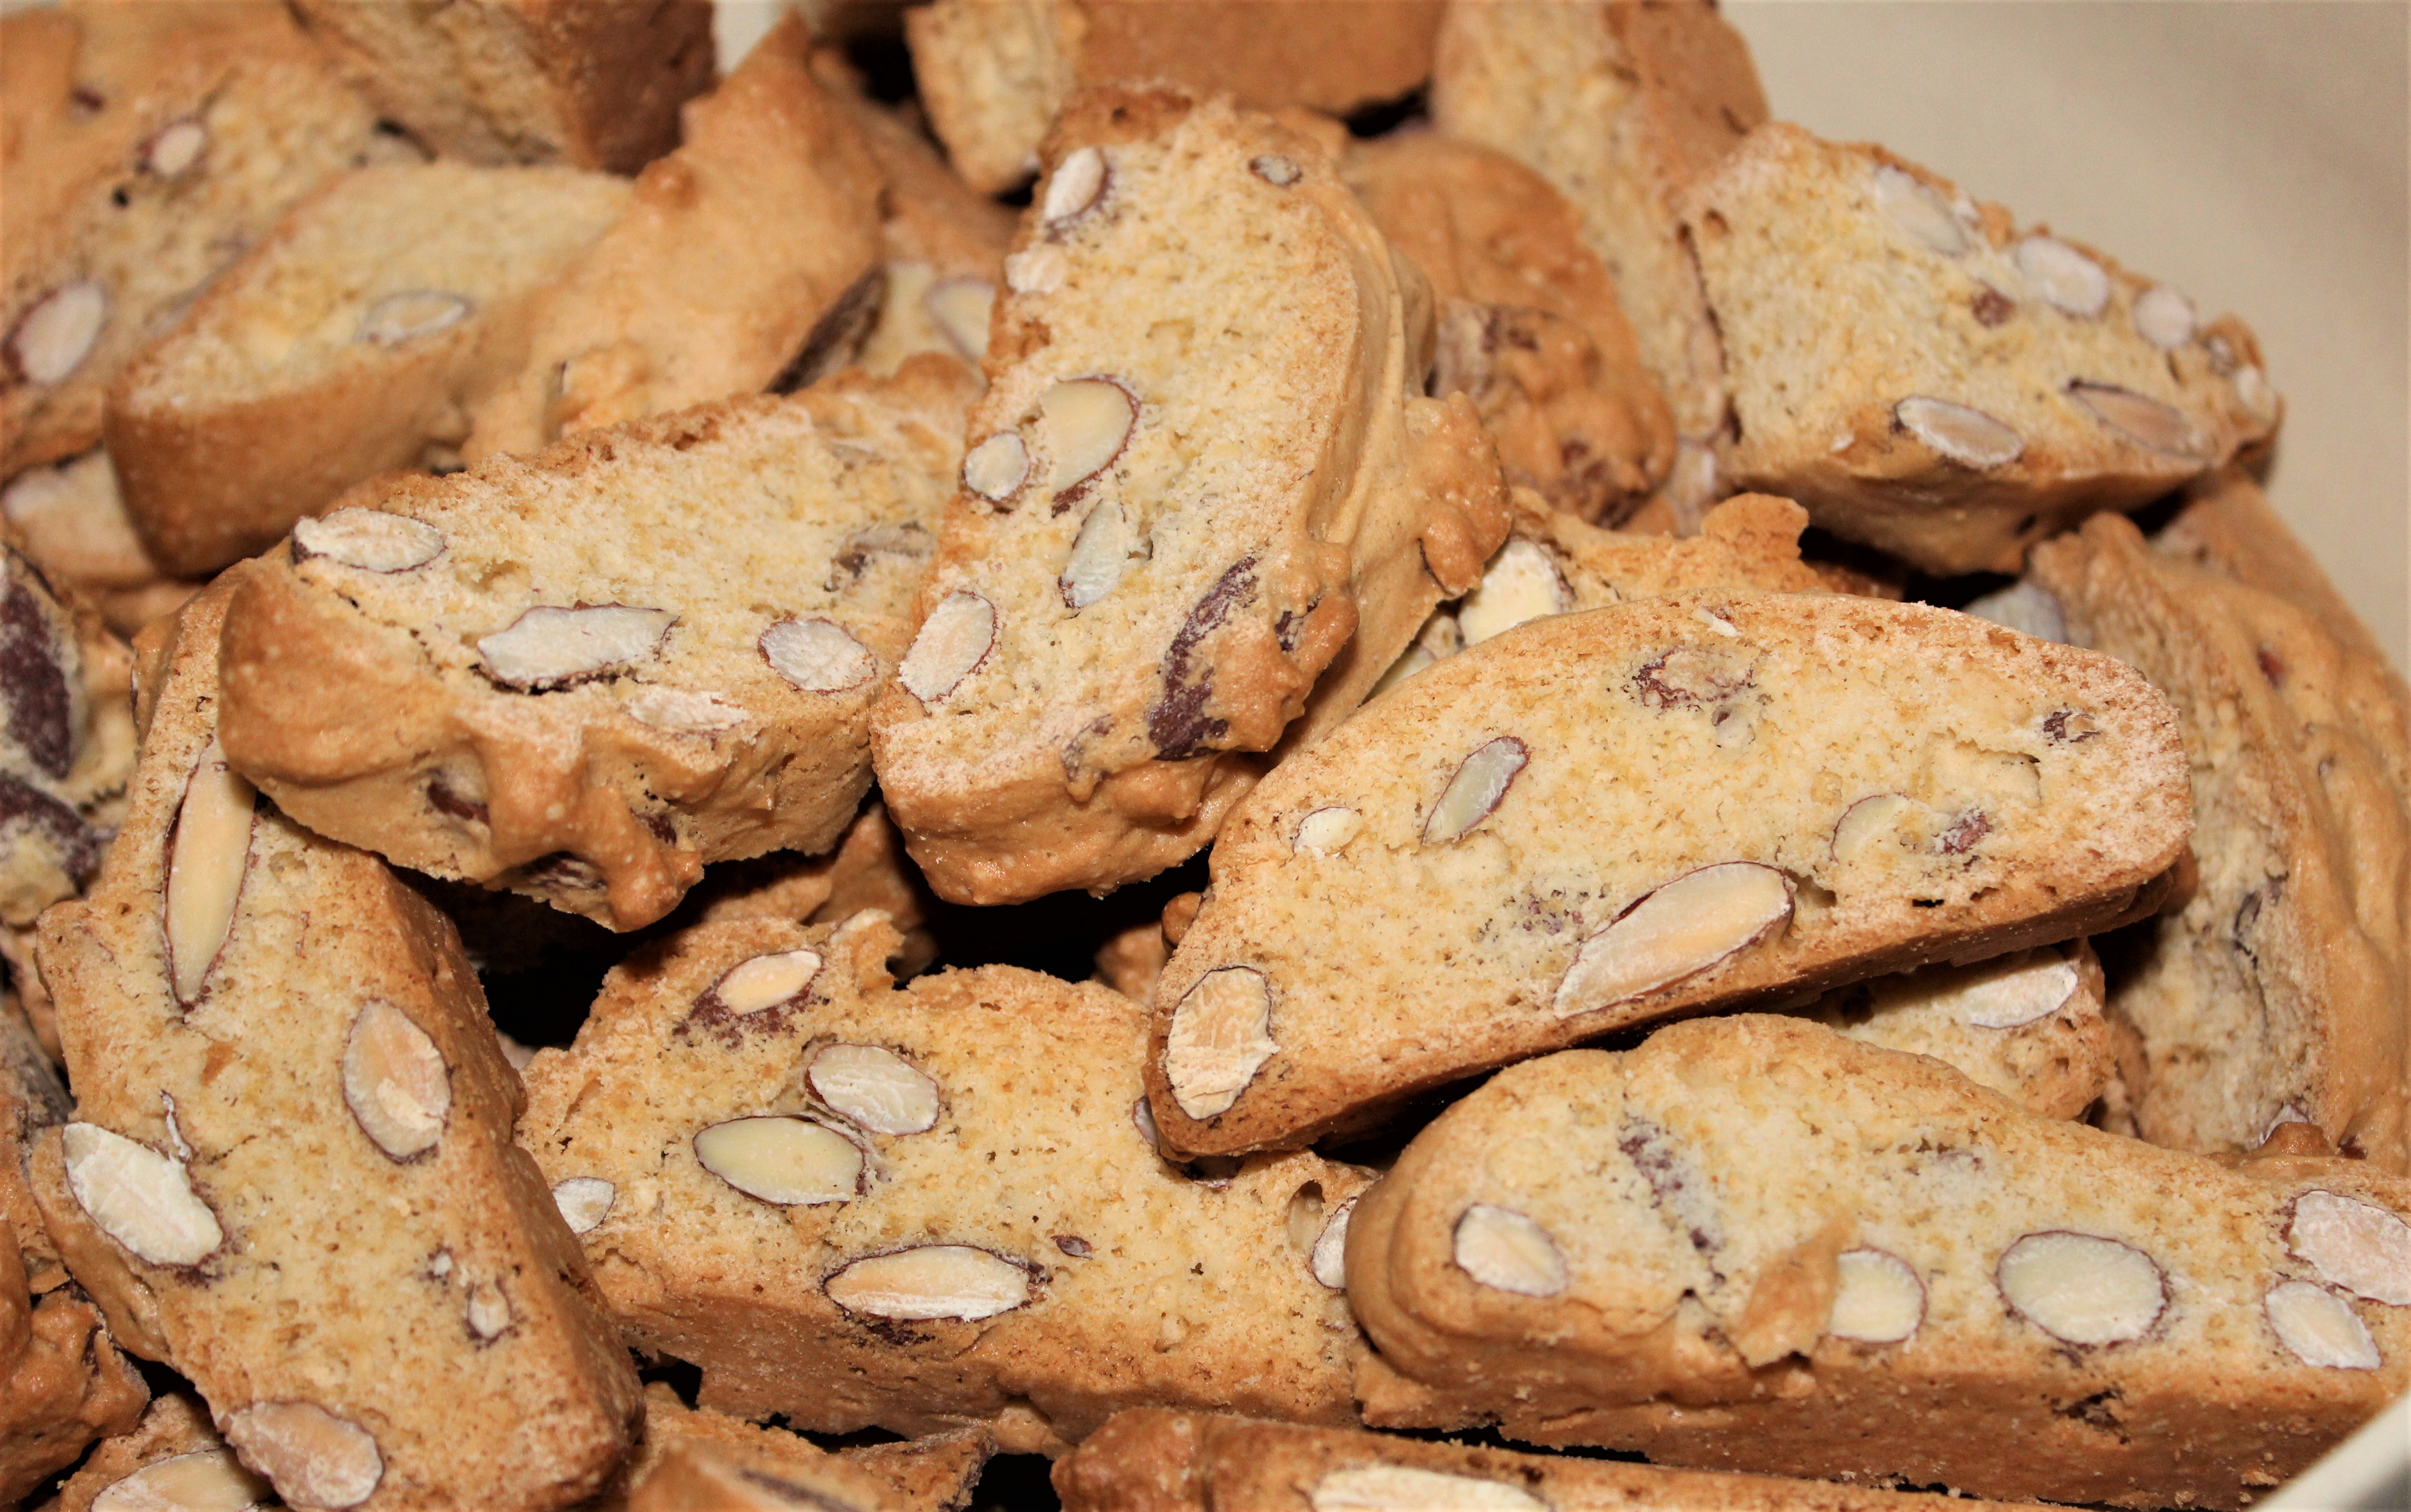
1550,861,1791,1018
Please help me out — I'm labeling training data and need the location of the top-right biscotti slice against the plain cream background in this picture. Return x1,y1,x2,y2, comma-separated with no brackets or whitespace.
1683,123,2278,574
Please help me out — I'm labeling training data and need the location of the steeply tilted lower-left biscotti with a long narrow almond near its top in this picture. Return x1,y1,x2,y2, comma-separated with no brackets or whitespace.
34,566,639,1512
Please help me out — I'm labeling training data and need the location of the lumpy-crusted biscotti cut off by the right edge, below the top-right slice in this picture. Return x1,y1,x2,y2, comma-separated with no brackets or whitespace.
2028,516,2411,1172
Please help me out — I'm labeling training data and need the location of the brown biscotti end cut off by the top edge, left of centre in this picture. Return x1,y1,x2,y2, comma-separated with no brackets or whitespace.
294,0,713,174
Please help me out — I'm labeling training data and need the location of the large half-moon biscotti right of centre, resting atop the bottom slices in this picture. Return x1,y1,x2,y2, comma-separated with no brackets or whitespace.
1147,591,2189,1153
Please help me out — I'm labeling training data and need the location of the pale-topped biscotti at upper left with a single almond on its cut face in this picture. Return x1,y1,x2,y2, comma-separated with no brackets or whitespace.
101,161,629,576
